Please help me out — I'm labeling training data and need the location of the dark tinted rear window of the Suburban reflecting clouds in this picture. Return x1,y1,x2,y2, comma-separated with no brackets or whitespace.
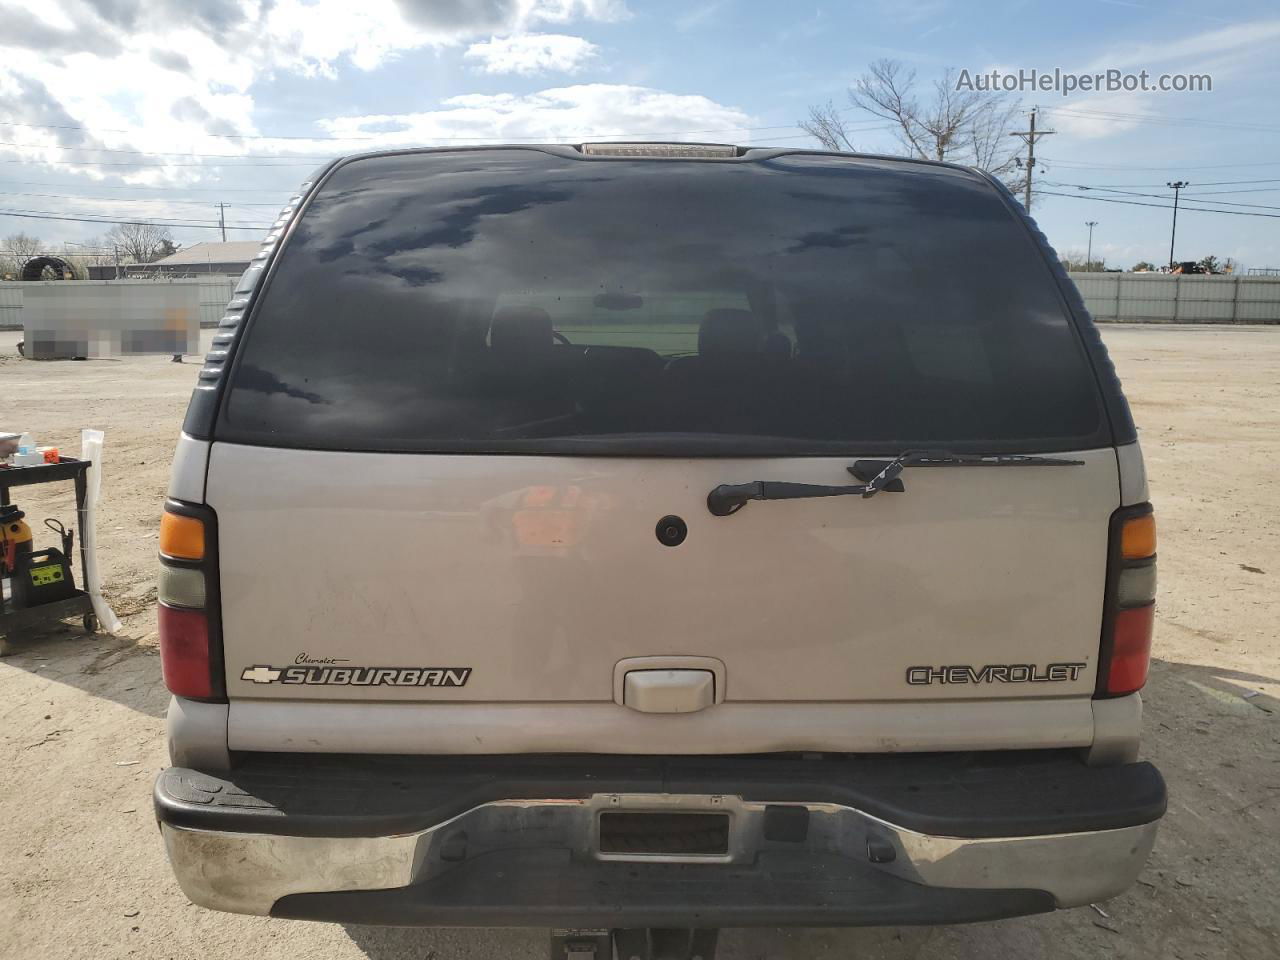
216,148,1108,456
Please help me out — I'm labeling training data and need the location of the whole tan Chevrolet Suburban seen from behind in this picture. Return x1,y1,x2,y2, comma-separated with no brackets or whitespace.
155,143,1165,957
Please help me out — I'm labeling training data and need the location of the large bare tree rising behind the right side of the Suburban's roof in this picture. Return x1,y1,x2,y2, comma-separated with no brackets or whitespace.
799,60,1025,189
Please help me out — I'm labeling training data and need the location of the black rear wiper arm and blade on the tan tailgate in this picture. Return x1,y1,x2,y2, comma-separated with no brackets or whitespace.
707,451,1084,517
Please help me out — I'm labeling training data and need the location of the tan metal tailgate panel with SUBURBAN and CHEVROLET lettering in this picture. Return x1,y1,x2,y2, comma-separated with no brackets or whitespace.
206,443,1119,701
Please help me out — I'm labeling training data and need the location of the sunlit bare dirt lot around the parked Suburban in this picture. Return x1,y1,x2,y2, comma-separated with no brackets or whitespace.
0,326,1280,960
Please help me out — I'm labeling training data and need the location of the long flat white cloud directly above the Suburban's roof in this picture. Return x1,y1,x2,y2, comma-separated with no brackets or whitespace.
324,83,753,147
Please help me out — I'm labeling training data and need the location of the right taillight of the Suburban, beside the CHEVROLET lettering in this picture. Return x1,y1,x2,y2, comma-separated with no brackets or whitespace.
1094,503,1156,696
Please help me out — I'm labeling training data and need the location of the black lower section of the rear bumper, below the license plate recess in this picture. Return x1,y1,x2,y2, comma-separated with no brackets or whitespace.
271,851,1053,928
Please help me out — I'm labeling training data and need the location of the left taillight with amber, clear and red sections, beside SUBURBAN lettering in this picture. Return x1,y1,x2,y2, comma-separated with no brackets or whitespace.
156,500,227,700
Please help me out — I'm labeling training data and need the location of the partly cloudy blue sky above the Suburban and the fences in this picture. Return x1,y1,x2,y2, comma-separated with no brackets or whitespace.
0,0,1280,268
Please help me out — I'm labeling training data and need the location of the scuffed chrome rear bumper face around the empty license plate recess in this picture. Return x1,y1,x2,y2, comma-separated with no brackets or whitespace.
161,792,1158,925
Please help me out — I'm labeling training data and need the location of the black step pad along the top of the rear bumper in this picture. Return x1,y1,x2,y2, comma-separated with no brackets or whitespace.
155,750,1166,837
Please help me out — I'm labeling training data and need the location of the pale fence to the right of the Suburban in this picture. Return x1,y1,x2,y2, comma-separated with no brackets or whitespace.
1070,273,1280,324
